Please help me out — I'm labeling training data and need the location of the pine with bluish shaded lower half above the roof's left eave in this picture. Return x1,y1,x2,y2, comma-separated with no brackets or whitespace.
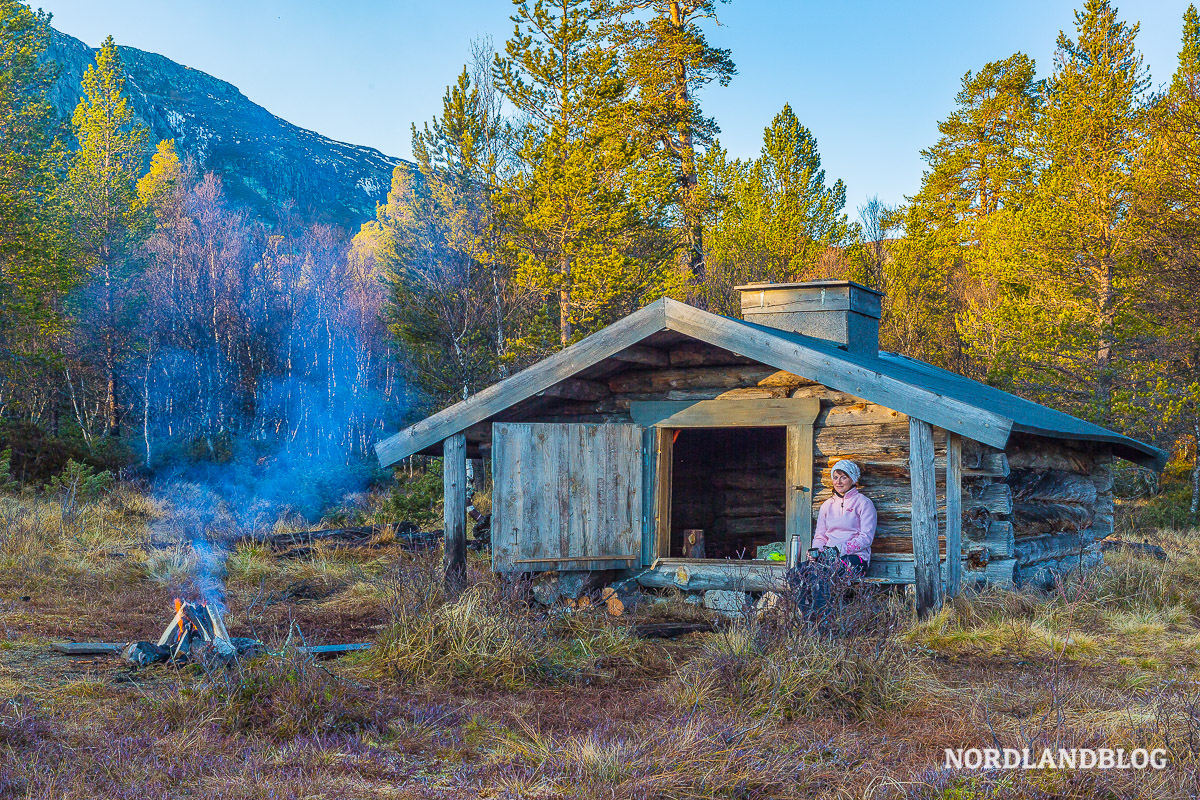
374,68,509,402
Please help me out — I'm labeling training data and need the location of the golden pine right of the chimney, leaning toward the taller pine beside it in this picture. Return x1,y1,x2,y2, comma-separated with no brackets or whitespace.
880,53,1038,374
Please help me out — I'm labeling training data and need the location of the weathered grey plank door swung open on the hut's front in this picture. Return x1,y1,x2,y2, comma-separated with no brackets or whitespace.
492,422,643,572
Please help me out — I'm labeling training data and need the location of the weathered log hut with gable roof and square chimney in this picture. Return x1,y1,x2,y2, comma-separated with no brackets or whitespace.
377,281,1164,610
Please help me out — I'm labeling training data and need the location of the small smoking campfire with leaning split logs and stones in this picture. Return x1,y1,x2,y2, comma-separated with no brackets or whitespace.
121,597,263,667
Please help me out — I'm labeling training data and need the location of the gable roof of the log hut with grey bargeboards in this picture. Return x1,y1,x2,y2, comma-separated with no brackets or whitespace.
376,297,1166,469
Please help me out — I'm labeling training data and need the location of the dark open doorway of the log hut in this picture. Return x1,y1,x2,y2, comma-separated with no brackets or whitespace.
671,427,787,559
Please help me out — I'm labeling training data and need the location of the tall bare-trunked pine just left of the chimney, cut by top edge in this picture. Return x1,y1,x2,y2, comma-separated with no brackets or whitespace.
607,0,737,295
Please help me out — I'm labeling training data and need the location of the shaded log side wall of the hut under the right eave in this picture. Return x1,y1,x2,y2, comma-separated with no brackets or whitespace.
1007,435,1112,587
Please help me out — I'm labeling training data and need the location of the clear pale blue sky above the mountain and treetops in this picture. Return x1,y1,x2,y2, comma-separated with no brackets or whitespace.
34,0,1188,216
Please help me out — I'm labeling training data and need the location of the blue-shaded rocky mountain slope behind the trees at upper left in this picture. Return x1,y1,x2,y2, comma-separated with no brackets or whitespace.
47,31,408,229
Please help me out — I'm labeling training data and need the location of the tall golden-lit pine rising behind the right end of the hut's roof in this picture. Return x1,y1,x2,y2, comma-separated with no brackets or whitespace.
989,0,1148,422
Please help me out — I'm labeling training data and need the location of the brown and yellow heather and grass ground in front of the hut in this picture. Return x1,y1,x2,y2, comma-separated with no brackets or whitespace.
0,488,1200,799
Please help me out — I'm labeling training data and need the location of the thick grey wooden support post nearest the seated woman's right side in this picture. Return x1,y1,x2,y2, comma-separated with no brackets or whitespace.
908,417,942,618
